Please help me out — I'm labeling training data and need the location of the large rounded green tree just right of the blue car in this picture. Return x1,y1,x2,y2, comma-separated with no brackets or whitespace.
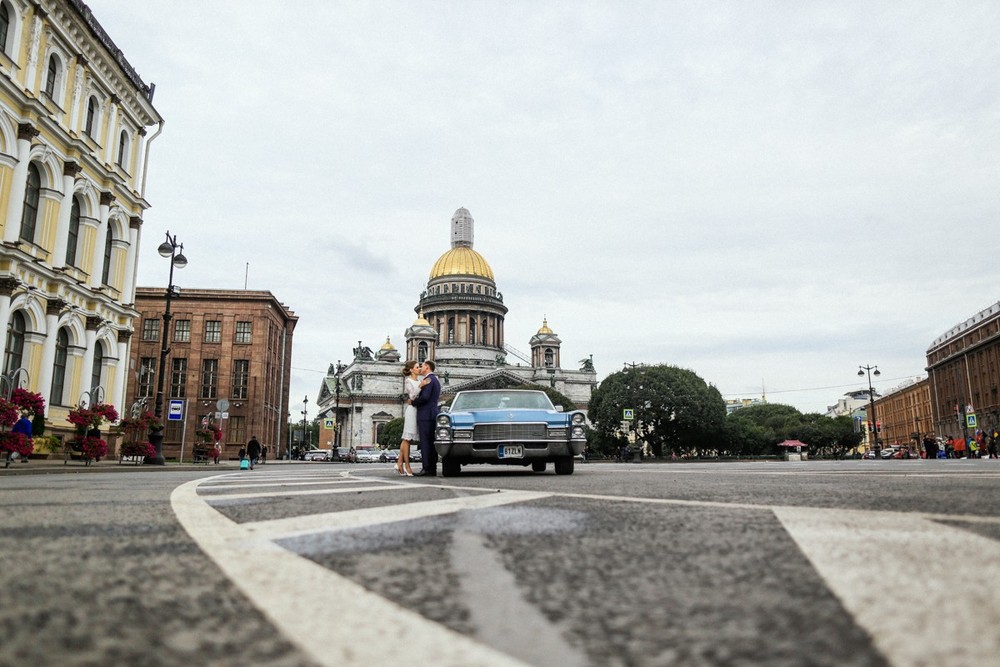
587,364,726,456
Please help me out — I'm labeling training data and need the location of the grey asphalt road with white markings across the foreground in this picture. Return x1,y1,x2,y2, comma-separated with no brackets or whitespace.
0,460,1000,667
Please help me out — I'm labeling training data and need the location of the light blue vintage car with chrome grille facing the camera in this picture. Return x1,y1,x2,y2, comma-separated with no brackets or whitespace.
434,389,587,477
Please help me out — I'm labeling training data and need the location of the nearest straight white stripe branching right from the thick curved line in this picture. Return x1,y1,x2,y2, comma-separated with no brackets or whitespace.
243,491,553,540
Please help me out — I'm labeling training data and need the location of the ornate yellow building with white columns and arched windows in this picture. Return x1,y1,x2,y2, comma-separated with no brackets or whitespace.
0,0,163,432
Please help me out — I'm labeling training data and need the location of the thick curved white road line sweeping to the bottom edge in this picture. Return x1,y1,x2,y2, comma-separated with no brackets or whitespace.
170,480,526,667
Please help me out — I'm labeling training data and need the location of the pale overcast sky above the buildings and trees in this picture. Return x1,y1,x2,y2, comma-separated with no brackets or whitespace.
89,0,1000,418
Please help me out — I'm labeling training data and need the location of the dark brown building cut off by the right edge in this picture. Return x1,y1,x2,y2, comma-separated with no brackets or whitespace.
927,303,1000,437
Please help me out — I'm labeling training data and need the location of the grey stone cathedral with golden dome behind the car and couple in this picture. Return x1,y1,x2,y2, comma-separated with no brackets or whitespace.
317,208,597,448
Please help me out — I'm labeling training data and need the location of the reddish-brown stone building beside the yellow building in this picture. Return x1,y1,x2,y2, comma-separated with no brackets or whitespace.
125,287,298,460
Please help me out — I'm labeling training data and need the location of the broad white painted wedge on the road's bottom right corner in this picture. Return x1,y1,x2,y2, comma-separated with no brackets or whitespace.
774,507,1000,667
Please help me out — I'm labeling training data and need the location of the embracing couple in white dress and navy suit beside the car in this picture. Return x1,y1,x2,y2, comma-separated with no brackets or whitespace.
396,359,441,477
